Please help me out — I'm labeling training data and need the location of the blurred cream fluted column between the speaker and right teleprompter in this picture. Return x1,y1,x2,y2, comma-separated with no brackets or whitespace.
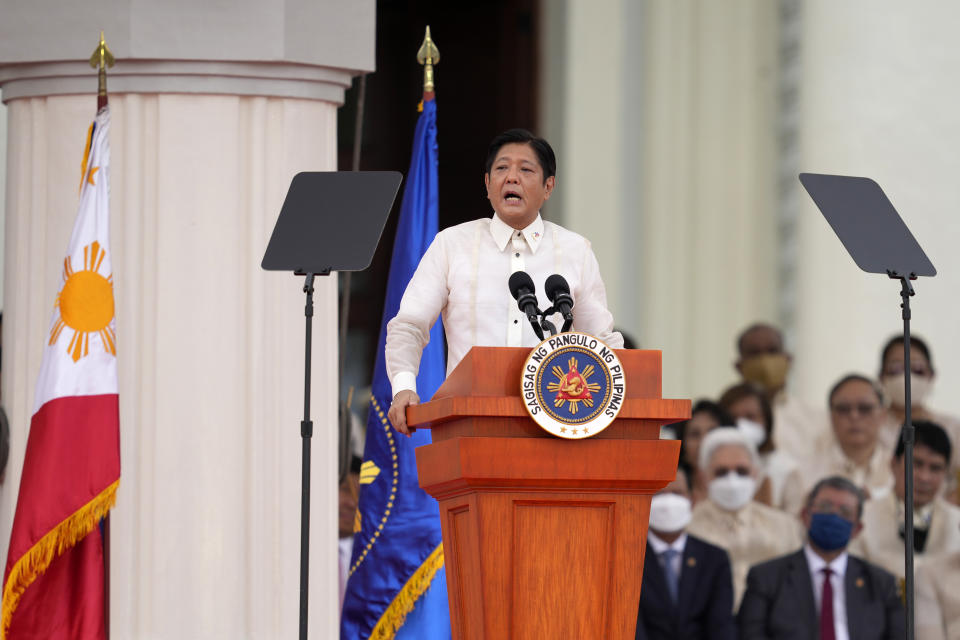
637,0,777,397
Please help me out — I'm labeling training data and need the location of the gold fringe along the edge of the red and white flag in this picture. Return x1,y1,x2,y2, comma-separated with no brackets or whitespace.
0,480,120,638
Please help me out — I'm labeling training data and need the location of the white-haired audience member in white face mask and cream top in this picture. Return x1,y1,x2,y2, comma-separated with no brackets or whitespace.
687,428,802,606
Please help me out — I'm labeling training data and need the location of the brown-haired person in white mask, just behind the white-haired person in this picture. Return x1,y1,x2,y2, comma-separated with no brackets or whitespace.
720,382,804,513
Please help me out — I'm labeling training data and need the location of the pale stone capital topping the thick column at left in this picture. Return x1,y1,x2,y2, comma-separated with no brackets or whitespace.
0,0,376,104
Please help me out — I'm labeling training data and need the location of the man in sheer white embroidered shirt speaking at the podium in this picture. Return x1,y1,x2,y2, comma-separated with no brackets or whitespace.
385,129,623,435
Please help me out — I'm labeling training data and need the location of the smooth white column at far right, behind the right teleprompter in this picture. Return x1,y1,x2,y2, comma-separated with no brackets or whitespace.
796,0,960,413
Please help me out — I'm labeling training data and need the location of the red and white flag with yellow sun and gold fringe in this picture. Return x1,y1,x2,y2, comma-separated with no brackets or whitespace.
0,107,120,638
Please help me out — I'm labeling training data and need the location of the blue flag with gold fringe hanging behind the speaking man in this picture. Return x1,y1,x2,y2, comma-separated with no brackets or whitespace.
340,100,450,640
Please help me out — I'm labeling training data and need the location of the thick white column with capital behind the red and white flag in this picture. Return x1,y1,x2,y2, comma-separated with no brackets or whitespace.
0,2,373,639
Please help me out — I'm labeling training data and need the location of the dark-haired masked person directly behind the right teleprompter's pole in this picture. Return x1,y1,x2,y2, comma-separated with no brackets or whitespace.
880,335,960,503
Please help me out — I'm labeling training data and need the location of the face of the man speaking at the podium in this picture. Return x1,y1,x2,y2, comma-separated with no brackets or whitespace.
483,143,556,229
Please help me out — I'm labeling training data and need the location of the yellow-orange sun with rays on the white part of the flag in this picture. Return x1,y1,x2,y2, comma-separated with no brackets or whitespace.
48,241,117,362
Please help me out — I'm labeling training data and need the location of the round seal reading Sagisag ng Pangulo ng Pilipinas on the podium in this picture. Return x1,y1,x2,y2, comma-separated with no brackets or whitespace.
520,331,626,439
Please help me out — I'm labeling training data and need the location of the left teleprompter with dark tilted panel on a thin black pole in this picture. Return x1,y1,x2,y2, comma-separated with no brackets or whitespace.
260,171,402,640
